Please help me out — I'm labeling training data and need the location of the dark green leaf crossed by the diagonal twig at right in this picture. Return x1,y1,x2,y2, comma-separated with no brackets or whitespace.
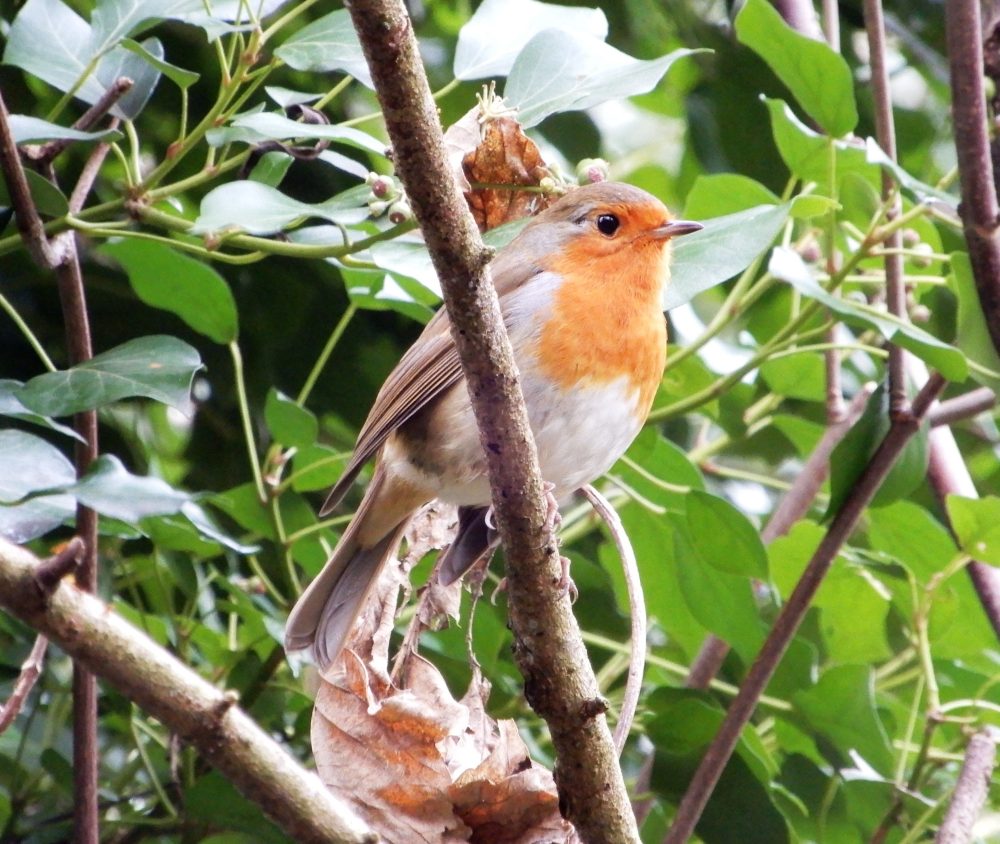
826,386,929,519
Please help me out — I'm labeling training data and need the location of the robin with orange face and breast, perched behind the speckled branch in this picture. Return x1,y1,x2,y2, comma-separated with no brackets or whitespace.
285,181,702,669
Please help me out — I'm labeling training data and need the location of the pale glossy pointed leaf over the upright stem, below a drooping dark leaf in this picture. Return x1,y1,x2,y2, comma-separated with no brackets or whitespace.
67,454,191,524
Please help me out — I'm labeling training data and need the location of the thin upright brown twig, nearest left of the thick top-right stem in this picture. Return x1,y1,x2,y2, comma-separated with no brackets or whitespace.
864,0,907,415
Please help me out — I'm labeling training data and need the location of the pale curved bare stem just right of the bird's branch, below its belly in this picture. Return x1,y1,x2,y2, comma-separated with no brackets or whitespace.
582,484,647,756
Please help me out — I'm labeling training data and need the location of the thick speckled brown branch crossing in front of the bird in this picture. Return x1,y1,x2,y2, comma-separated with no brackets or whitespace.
349,0,638,842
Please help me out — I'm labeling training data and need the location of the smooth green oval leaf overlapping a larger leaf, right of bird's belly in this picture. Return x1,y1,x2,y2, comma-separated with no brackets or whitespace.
685,490,767,580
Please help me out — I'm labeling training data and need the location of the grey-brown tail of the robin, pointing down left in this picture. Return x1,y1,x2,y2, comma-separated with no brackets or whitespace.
285,470,410,668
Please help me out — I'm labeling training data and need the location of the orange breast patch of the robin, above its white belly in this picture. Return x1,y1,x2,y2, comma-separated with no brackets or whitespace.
538,238,667,419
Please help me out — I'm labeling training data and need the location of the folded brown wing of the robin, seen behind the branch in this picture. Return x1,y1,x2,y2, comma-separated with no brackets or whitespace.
320,241,538,516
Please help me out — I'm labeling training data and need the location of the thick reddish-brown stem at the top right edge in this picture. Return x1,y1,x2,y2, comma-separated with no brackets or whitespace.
944,0,1000,352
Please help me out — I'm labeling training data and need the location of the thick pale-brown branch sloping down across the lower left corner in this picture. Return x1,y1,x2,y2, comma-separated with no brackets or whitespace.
0,539,377,844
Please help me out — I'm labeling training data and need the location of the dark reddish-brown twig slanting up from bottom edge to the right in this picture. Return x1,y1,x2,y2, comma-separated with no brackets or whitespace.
665,373,945,844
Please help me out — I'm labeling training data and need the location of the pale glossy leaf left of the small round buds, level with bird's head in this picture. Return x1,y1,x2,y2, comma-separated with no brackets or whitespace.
191,181,368,235
